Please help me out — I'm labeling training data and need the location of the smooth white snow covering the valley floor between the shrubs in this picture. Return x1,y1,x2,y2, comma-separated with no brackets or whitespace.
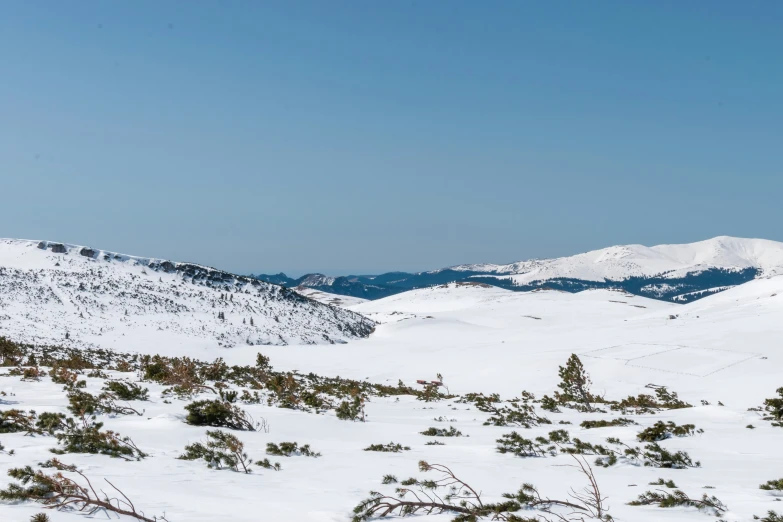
0,258,783,522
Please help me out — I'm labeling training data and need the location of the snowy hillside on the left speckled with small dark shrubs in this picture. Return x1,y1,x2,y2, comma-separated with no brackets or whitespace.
0,239,374,351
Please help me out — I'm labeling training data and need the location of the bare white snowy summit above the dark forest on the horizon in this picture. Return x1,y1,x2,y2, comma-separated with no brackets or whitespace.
451,236,783,284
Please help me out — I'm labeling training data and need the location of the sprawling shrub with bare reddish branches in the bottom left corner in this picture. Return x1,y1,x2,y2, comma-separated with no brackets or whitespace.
0,459,166,522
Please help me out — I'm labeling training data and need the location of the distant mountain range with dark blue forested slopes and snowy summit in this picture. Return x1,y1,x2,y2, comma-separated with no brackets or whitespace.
250,236,783,303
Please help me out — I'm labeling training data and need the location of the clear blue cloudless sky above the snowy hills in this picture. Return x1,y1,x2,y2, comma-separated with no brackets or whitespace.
0,0,783,274
